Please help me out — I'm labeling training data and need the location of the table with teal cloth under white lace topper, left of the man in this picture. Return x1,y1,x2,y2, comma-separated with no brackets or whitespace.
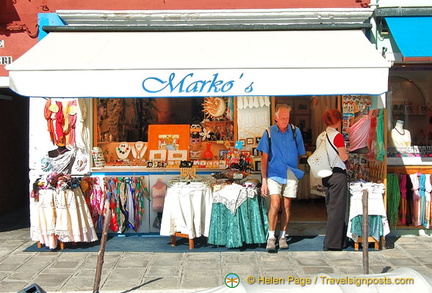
208,184,268,248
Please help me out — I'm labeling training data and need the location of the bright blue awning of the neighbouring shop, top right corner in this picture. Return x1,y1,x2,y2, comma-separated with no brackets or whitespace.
385,16,432,61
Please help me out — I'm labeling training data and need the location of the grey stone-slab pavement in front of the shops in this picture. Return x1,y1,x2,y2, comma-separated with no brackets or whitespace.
0,209,432,292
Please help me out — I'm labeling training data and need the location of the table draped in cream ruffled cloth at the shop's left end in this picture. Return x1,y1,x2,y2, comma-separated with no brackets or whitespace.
30,187,98,249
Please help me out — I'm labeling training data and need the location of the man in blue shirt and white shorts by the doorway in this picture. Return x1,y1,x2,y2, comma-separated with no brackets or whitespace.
257,104,306,251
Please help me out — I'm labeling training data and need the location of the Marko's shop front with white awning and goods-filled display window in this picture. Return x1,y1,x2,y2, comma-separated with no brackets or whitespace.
8,9,390,246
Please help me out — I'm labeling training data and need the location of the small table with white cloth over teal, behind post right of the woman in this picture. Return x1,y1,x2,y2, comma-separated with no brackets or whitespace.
347,183,390,250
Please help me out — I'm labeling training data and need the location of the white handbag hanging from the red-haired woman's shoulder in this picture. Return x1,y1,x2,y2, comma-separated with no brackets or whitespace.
307,131,333,178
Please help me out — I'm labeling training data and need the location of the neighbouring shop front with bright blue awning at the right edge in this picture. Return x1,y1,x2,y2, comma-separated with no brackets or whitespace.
373,1,432,234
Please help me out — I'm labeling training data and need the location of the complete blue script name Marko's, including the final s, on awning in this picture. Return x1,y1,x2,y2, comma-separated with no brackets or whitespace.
142,72,254,95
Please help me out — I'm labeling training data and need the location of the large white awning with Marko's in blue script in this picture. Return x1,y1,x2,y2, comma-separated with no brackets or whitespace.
6,30,390,97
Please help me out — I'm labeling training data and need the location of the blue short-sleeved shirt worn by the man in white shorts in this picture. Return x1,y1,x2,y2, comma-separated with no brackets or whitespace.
257,124,306,184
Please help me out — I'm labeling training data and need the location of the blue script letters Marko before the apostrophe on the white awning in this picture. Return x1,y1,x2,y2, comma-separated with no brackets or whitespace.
142,72,235,93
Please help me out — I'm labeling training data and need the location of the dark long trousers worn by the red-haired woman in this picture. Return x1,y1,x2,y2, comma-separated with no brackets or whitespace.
323,173,348,250
